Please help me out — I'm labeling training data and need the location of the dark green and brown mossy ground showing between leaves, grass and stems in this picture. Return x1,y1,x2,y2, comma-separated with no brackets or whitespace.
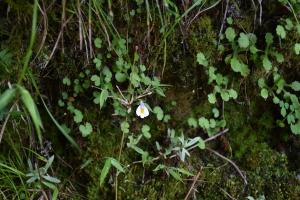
0,1,300,200
